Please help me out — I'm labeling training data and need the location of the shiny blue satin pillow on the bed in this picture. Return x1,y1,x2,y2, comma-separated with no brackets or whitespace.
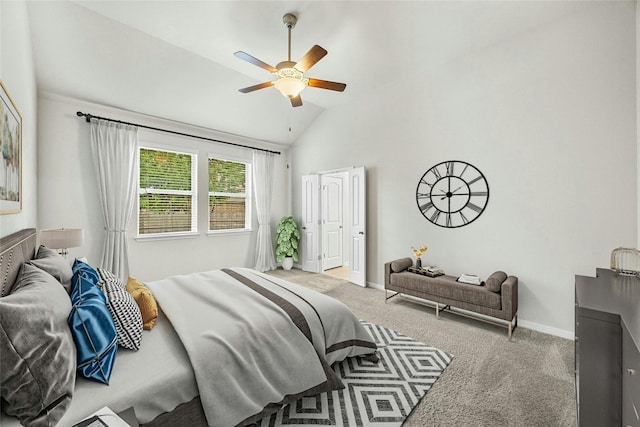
68,260,118,384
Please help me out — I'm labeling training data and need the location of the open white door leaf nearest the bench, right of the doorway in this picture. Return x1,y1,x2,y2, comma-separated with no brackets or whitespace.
349,167,367,287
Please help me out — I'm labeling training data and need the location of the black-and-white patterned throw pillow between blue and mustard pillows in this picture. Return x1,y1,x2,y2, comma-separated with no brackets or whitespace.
97,268,142,350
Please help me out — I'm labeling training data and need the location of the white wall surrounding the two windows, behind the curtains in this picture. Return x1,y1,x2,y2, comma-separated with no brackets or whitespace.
38,94,290,280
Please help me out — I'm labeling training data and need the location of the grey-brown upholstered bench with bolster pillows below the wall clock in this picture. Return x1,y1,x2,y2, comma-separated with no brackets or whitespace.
384,258,518,340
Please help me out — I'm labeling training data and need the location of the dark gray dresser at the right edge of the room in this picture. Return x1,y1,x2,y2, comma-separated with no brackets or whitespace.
575,268,640,427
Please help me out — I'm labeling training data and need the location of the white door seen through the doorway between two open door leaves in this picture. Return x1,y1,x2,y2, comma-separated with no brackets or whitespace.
320,175,343,270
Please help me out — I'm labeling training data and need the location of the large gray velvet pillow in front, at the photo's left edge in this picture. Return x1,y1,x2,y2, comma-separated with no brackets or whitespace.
0,263,76,426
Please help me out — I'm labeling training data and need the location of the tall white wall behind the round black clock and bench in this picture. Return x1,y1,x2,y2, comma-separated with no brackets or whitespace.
292,2,638,336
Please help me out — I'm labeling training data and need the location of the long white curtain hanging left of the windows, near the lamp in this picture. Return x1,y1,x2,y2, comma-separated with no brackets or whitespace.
91,119,138,283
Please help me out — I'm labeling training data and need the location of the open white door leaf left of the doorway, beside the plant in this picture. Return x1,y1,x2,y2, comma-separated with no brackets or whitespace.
299,175,320,273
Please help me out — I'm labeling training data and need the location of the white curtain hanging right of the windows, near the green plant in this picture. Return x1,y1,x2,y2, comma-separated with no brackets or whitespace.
253,150,276,271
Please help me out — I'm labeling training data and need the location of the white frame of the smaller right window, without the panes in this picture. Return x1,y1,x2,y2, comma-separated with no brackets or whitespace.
207,153,253,236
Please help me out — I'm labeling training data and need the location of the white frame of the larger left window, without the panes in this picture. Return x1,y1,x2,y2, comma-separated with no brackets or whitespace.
136,142,199,240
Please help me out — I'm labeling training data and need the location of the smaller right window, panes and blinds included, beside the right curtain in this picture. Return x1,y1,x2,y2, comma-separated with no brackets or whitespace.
209,157,251,231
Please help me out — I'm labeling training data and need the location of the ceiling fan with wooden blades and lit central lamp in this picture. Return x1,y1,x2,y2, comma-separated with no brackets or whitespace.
234,13,347,107
